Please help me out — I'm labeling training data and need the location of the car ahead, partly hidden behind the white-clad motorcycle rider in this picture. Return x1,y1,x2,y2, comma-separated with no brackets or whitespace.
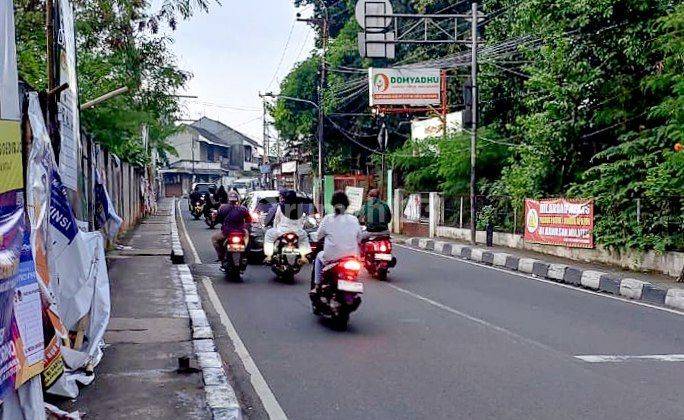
243,190,320,262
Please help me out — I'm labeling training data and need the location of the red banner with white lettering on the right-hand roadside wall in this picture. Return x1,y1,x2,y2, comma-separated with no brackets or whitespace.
525,198,594,248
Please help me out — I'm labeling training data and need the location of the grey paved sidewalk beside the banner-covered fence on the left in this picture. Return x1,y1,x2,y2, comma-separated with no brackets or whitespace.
59,200,212,419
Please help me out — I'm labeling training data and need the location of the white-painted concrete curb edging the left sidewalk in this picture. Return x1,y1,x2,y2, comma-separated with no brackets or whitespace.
171,200,242,420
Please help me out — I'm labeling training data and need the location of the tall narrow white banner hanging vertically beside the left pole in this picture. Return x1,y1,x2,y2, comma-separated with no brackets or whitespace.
57,0,81,191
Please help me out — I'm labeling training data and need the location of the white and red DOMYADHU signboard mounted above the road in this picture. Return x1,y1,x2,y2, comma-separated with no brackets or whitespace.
368,68,441,106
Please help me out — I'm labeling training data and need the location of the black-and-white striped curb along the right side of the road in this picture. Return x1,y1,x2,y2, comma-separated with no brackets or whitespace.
405,238,684,310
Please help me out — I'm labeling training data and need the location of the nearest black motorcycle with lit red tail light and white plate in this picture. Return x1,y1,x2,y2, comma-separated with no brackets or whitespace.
309,257,363,330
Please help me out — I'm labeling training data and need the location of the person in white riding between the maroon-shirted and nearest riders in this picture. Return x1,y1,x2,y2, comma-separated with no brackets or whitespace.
264,190,311,264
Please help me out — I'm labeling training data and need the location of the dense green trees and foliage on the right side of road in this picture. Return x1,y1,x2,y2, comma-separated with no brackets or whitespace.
276,0,684,250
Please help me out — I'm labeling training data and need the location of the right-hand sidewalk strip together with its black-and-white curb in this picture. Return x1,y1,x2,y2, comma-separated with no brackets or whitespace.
396,235,684,310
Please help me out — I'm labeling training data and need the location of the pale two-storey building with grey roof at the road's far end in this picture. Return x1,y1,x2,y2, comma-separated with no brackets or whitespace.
160,117,261,196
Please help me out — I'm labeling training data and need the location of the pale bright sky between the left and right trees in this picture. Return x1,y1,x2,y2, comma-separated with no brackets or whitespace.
169,0,314,142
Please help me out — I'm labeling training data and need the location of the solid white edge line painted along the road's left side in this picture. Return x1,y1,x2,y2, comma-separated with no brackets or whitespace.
178,200,287,420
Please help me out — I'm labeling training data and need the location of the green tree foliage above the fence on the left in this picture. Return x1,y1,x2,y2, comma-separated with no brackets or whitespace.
14,0,215,164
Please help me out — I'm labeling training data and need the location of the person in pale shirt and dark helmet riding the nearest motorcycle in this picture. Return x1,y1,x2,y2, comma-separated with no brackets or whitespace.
311,191,361,293
